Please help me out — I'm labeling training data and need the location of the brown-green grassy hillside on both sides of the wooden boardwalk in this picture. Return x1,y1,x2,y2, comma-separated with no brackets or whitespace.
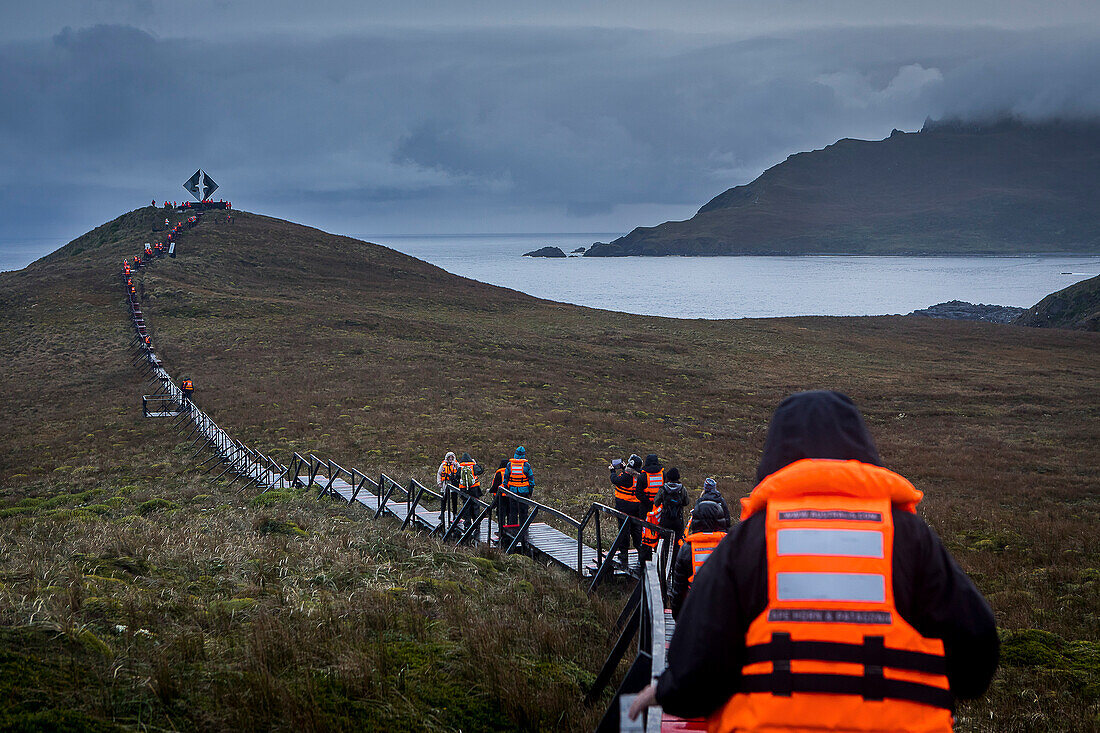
0,209,1100,731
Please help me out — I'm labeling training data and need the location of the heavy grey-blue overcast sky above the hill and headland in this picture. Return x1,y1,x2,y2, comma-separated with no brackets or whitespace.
0,0,1100,267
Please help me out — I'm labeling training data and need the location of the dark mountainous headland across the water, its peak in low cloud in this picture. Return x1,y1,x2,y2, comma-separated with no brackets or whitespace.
585,120,1100,256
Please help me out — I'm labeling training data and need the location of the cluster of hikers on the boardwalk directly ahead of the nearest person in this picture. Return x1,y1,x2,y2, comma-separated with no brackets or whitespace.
607,453,729,617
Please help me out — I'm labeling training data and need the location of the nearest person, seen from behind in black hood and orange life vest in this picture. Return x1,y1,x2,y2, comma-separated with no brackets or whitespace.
630,392,1000,733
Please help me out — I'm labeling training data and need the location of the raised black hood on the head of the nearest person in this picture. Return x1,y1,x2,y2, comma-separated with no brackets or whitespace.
757,390,882,483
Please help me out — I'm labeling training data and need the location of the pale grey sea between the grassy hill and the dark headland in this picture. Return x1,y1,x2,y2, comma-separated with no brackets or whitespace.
363,232,1100,318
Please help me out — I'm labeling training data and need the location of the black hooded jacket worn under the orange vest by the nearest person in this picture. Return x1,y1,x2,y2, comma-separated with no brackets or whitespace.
630,391,1000,730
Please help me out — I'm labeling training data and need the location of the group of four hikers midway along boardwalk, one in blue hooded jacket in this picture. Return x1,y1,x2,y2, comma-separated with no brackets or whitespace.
436,446,535,541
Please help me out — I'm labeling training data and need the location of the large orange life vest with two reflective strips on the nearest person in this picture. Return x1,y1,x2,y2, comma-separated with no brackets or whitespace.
708,459,954,733
